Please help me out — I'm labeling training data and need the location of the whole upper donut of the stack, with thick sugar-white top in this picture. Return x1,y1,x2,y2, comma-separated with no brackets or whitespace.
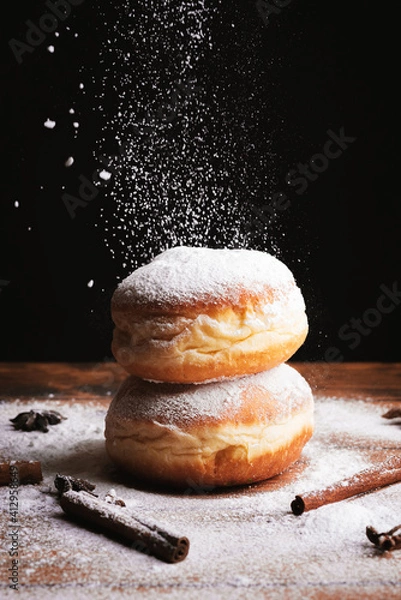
111,246,308,383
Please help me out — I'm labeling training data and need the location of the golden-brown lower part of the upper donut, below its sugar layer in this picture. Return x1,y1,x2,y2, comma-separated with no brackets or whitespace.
112,302,308,383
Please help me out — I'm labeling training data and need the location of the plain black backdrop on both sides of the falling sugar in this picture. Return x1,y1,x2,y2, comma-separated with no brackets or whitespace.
0,0,401,361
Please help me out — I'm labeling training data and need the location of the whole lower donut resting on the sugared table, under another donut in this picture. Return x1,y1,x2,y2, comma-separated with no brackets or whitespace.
105,364,313,488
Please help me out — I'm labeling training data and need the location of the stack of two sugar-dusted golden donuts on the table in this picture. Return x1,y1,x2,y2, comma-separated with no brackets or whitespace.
105,246,313,488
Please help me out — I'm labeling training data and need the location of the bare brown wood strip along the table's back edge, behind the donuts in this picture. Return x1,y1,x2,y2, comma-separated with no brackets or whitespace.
0,361,401,401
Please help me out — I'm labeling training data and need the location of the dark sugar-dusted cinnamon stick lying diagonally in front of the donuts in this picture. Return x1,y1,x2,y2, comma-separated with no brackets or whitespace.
60,490,189,563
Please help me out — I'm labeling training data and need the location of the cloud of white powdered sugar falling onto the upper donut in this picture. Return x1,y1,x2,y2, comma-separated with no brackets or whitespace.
88,0,281,271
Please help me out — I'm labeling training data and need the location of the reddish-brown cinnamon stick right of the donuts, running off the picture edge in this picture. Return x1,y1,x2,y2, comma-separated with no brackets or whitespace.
291,456,401,515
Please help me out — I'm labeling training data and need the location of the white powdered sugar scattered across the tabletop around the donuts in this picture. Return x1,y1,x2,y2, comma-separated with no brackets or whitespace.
0,397,401,600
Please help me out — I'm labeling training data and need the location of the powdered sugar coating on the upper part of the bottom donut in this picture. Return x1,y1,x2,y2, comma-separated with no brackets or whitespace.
105,364,312,427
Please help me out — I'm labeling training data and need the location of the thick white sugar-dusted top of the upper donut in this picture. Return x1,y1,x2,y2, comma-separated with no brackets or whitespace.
113,246,304,310
